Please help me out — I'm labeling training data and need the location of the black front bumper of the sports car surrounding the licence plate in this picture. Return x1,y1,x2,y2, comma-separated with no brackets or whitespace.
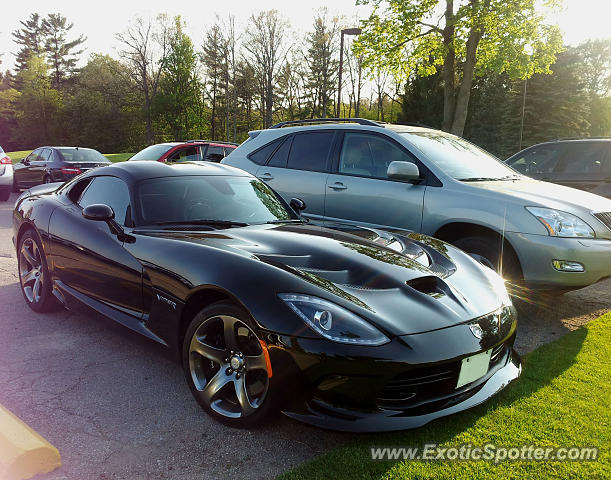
270,310,521,432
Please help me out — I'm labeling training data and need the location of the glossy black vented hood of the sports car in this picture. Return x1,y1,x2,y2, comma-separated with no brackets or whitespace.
142,224,501,335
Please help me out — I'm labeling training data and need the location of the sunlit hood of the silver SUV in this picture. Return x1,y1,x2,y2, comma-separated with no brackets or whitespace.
468,177,611,214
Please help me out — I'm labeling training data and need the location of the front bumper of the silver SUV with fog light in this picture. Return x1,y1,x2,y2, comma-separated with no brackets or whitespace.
506,232,611,289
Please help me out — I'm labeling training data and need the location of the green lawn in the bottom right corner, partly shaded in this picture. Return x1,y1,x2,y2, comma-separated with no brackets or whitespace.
279,312,611,480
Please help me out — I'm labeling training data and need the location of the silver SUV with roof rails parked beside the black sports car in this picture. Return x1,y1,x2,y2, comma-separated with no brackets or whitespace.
222,119,611,293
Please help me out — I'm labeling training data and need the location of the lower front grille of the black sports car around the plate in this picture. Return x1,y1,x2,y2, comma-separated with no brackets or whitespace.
376,342,509,415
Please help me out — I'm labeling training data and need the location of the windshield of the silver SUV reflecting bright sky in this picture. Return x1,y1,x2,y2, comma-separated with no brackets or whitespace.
401,132,518,181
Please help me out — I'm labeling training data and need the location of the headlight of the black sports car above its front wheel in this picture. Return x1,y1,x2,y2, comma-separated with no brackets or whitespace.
278,293,389,345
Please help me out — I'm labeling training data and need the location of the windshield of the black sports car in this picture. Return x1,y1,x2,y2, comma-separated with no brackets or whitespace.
136,175,298,226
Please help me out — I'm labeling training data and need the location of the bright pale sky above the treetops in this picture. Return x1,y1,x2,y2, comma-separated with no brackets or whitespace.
0,0,611,70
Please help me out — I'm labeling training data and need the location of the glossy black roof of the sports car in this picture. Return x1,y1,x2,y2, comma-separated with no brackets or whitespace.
88,160,254,183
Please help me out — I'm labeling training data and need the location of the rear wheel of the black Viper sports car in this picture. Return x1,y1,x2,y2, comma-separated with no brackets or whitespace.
17,230,59,313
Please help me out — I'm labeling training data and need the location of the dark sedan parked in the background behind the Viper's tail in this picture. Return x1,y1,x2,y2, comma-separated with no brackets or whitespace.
13,147,110,192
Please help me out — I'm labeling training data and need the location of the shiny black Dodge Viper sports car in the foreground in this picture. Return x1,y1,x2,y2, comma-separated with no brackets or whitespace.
13,162,521,431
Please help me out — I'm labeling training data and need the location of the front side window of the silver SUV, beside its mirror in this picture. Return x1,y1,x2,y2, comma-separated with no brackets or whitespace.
338,132,414,178
